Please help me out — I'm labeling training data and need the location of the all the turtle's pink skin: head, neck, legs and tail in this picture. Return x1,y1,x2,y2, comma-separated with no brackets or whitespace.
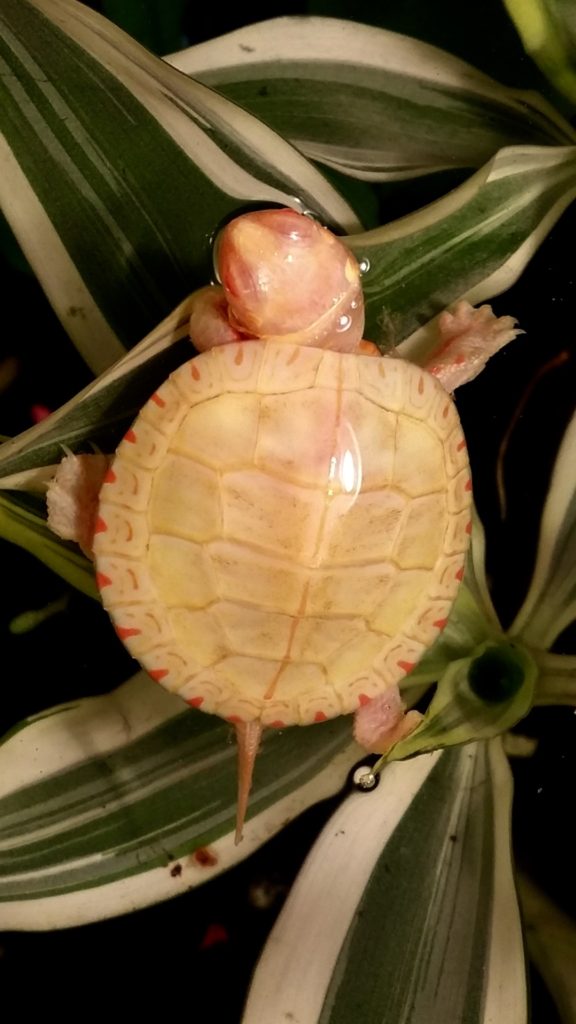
48,210,521,843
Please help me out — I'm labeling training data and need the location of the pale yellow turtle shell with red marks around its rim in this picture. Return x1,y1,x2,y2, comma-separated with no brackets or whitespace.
94,341,470,727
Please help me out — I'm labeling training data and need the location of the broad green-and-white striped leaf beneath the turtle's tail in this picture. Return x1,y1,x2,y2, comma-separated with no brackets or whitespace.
0,672,360,930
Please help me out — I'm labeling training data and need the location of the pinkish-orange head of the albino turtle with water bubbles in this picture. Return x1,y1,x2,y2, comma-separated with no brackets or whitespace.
215,209,364,351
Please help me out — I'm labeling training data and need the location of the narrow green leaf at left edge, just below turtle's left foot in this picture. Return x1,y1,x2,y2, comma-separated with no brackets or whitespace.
0,494,98,598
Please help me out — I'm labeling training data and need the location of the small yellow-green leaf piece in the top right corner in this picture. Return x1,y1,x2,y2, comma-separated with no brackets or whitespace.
504,0,576,104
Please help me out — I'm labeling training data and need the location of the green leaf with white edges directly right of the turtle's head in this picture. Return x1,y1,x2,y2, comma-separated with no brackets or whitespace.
347,146,576,352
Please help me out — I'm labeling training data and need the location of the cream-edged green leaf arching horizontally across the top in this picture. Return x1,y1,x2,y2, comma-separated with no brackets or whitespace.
166,17,576,181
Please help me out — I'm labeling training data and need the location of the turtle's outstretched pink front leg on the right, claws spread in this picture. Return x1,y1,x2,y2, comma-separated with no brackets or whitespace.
425,300,524,392
